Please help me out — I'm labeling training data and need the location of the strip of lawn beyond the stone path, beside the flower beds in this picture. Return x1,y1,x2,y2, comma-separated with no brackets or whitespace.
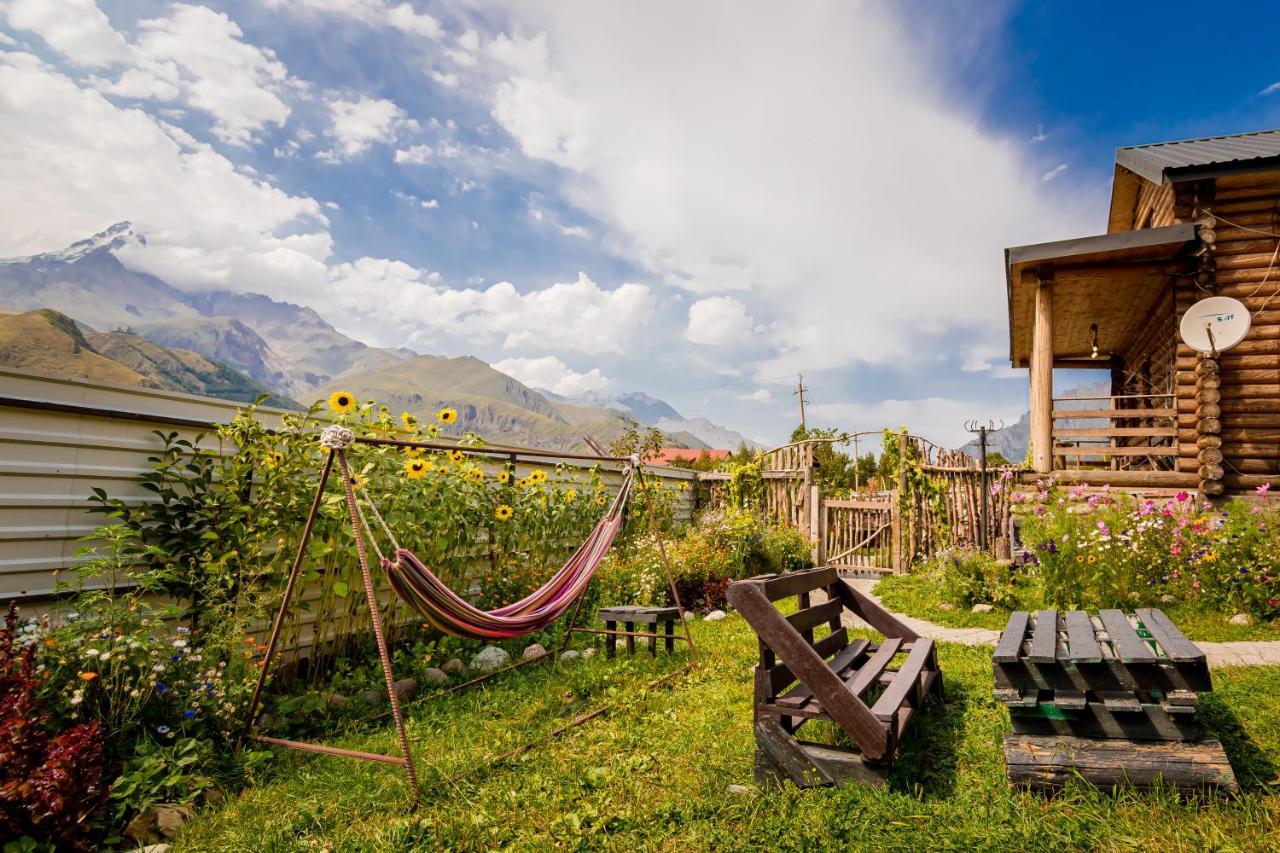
876,574,1280,643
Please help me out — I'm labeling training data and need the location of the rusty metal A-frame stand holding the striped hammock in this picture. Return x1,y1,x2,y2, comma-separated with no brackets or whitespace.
237,425,695,806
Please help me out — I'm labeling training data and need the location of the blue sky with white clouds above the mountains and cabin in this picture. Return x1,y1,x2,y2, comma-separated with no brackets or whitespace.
0,0,1280,443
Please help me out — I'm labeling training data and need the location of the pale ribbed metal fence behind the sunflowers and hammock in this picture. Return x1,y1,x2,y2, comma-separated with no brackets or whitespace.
0,369,696,653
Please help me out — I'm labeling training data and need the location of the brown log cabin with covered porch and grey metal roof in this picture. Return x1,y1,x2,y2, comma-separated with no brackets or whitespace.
1005,131,1280,497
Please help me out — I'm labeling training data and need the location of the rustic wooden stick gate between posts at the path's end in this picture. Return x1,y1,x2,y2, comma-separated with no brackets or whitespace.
822,492,901,574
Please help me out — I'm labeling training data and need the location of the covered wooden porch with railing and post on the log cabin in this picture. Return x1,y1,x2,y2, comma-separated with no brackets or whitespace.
1005,223,1198,491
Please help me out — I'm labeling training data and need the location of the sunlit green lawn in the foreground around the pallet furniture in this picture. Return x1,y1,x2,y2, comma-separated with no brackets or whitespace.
175,615,1280,850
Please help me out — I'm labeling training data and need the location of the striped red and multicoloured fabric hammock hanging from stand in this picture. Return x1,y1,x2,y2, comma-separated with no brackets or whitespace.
381,470,634,639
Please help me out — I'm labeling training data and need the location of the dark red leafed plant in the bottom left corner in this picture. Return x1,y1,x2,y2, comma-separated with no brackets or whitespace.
0,605,108,849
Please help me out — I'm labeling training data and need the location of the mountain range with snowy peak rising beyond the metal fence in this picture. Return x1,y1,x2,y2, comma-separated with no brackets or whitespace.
0,223,759,450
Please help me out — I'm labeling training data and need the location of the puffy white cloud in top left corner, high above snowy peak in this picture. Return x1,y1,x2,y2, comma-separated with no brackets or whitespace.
6,0,297,145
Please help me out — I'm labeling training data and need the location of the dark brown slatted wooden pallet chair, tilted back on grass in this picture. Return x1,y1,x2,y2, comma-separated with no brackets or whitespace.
728,567,942,786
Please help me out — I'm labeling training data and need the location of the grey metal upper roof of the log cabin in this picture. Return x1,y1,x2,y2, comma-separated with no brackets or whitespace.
1116,131,1280,183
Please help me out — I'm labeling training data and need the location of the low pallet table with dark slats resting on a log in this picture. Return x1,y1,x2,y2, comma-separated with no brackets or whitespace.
992,608,1235,792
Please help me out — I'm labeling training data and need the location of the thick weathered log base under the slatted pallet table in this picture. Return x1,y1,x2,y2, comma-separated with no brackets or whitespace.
1004,734,1239,795
